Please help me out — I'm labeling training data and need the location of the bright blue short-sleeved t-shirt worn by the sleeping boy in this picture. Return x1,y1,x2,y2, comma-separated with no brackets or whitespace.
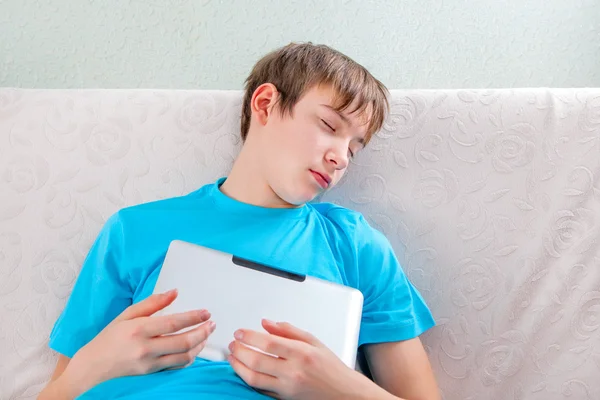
50,178,434,399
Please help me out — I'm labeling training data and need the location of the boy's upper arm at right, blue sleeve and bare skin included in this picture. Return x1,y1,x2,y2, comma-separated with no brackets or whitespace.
346,219,440,400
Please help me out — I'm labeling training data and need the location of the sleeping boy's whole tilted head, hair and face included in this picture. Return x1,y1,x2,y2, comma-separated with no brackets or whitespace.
241,43,388,205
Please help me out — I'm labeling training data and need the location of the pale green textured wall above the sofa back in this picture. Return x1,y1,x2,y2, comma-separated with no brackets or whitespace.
0,0,600,89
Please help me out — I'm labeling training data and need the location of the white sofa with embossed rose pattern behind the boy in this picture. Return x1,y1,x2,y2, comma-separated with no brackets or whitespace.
0,89,600,400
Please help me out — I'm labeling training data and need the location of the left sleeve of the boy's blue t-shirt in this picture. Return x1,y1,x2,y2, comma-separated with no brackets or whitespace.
50,213,133,357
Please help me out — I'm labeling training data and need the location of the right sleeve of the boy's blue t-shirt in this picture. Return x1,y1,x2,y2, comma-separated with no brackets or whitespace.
356,216,435,345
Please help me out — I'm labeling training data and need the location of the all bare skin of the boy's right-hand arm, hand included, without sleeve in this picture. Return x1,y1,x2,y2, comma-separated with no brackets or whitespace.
229,320,440,400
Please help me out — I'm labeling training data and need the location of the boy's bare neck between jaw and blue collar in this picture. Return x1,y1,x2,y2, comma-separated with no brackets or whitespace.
220,139,297,208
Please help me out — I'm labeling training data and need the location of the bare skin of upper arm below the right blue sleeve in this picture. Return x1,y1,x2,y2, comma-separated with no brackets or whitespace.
365,337,440,400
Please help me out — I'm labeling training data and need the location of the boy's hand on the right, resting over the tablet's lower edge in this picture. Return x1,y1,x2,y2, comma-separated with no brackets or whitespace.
228,320,372,399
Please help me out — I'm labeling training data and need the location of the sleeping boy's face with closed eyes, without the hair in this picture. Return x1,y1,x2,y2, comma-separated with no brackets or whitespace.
250,85,368,205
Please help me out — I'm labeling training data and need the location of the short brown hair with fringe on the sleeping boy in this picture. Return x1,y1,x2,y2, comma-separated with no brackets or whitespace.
241,42,389,144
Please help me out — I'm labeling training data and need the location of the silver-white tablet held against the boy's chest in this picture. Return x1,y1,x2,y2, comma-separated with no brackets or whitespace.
154,240,363,368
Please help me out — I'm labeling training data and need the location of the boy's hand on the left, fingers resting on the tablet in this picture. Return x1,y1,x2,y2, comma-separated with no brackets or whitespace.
65,290,215,388
